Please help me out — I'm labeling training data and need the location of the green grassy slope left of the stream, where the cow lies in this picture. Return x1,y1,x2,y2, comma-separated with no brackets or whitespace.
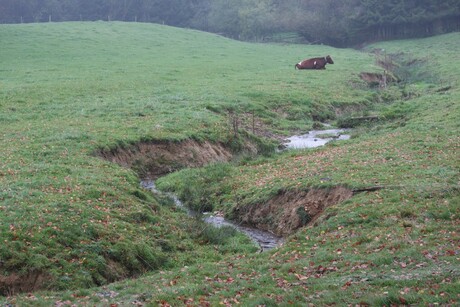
0,22,374,294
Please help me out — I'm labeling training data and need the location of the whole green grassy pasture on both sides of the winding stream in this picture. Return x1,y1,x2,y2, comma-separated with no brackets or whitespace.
0,22,460,306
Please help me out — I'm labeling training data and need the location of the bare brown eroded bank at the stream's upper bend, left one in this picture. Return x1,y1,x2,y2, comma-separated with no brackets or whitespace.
96,140,233,179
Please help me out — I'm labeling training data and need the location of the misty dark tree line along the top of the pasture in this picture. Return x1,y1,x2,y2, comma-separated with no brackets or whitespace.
0,0,460,47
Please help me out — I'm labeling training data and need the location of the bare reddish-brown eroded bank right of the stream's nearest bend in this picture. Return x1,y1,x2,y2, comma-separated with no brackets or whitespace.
235,186,353,236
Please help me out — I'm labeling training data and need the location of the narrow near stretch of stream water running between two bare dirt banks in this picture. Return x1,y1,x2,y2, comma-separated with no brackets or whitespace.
141,180,283,251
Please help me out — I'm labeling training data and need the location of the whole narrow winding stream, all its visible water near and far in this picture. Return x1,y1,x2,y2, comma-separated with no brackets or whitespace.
141,129,350,251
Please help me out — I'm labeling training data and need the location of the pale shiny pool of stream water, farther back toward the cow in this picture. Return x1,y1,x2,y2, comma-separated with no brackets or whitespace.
283,129,350,149
